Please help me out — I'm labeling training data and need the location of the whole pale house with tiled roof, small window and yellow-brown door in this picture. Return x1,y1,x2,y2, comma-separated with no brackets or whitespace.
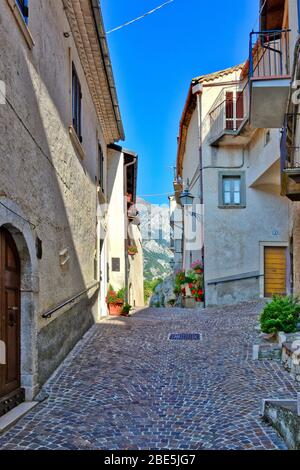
174,62,292,305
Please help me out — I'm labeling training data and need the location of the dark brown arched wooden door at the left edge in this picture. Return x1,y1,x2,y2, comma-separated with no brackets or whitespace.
0,229,20,400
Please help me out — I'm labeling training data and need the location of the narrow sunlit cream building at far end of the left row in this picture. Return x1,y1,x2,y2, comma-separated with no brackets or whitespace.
108,145,144,307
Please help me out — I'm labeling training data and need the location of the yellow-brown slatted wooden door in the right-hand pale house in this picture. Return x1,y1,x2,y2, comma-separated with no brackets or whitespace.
264,246,287,297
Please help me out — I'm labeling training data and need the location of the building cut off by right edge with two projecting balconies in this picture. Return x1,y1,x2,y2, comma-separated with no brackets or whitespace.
251,0,300,295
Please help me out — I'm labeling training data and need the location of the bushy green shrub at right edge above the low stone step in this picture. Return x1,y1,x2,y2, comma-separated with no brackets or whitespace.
260,296,300,333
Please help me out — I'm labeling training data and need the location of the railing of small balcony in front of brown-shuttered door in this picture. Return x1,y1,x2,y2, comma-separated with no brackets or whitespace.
209,82,249,144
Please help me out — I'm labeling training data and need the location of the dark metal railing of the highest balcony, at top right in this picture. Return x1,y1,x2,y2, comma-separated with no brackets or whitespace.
249,29,290,79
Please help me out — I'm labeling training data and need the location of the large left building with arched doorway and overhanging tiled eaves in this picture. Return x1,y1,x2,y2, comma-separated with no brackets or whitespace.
0,0,142,414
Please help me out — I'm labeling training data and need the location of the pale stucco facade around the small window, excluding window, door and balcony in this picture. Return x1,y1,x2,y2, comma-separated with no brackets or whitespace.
176,65,291,306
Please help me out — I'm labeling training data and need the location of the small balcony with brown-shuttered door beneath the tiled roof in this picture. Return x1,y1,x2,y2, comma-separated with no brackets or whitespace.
204,82,253,146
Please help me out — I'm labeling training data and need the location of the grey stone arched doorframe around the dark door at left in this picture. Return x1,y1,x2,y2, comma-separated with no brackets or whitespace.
0,198,39,401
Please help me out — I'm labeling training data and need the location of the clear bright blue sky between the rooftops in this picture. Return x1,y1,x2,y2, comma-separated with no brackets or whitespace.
101,0,258,204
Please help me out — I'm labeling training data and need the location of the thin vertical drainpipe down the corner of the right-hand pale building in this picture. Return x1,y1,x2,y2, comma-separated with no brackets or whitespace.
192,83,205,304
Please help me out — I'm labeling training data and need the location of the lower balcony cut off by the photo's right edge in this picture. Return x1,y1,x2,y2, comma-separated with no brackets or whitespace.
280,113,300,201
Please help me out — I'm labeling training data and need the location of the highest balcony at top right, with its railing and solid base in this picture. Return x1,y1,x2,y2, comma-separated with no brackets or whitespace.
249,30,291,129
